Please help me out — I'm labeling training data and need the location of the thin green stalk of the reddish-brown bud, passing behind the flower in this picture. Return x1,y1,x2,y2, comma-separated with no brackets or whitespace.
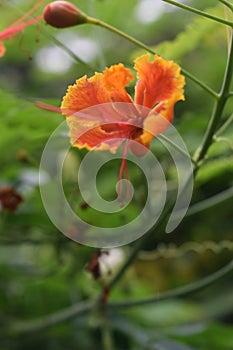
87,16,218,98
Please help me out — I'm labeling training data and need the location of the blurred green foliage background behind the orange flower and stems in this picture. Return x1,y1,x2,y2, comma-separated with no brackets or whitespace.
0,0,233,350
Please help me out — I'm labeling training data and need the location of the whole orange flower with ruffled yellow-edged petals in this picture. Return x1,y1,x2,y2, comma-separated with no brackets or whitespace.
61,54,185,155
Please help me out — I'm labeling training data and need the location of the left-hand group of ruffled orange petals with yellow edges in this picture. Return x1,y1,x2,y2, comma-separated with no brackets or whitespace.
61,64,135,151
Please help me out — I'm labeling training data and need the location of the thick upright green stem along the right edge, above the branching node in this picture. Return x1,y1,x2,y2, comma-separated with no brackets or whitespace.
193,33,233,169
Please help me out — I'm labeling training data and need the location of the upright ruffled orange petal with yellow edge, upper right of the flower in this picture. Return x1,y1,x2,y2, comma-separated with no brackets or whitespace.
134,54,185,108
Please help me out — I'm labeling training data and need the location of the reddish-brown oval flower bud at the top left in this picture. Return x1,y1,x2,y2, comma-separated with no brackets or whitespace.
43,1,87,28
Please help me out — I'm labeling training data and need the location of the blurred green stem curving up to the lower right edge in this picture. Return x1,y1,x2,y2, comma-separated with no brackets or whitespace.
107,260,233,308
